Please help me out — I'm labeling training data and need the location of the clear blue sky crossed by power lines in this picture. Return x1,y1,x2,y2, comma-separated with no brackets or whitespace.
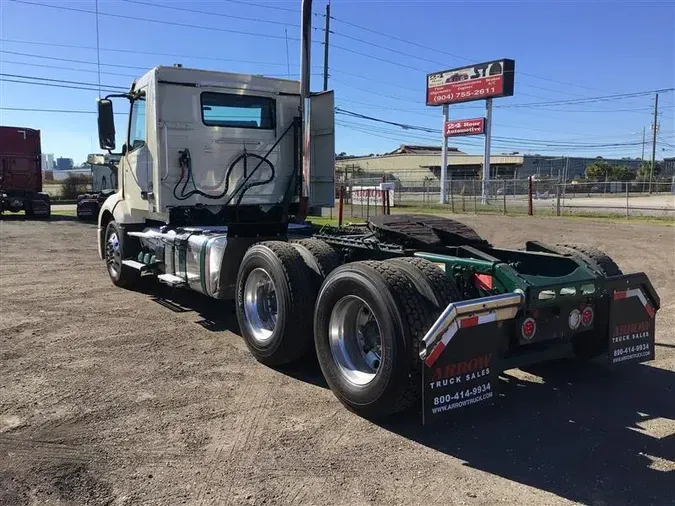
0,0,675,163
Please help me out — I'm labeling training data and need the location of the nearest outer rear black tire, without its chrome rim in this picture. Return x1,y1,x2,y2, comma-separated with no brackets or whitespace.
314,261,431,418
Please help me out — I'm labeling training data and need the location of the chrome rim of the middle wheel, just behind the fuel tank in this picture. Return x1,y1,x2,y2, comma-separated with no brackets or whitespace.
244,268,279,345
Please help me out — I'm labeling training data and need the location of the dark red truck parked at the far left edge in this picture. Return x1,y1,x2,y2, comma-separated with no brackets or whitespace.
0,126,51,218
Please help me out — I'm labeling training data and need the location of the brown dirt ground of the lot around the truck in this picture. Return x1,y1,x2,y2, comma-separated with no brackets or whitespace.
0,216,675,506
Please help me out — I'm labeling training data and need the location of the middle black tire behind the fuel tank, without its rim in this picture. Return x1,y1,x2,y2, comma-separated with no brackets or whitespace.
236,241,320,366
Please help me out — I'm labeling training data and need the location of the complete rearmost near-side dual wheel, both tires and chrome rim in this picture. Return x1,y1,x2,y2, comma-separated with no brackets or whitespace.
314,259,452,418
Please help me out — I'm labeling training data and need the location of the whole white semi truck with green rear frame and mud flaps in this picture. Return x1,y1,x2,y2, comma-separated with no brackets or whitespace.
98,0,659,421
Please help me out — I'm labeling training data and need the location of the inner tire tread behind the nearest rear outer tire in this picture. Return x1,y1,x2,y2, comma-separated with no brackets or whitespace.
387,257,462,311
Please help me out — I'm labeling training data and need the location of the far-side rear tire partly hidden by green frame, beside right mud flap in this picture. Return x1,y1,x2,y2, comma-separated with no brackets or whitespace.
556,243,623,360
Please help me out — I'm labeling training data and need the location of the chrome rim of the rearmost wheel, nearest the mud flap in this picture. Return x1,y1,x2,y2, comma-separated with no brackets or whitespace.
328,295,382,386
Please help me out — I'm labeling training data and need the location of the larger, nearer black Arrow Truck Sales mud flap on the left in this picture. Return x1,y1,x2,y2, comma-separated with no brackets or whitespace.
422,315,506,425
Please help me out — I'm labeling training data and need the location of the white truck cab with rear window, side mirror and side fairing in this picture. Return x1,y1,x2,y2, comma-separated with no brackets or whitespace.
99,66,334,247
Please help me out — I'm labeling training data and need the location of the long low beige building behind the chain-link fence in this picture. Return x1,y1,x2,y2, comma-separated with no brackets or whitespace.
335,144,641,185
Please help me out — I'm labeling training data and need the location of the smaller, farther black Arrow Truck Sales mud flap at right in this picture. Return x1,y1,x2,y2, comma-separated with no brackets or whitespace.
605,273,660,367
